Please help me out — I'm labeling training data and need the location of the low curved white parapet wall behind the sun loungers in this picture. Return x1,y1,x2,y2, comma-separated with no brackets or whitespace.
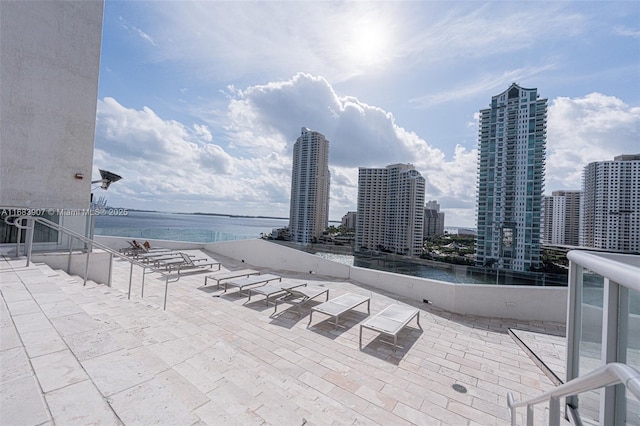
205,240,567,323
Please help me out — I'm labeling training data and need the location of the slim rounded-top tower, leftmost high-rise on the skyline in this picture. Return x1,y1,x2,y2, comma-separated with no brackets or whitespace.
289,127,331,244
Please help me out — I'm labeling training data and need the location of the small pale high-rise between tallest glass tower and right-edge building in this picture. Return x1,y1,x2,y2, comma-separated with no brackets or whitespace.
542,191,582,246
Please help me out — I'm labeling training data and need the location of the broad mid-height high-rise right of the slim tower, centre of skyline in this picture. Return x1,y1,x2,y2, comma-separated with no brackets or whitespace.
355,164,425,256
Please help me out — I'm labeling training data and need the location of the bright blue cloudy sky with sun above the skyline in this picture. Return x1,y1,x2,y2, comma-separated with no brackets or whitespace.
93,0,640,227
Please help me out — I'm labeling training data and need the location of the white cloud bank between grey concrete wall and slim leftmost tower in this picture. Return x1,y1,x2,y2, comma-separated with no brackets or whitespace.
94,98,289,214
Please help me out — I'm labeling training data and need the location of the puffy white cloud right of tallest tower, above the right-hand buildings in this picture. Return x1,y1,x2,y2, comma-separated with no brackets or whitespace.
545,93,640,193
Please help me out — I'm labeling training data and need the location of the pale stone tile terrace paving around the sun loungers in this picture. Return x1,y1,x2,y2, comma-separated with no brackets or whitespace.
0,253,562,425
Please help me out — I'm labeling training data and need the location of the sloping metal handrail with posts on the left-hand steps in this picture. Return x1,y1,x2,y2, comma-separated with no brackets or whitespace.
4,215,180,310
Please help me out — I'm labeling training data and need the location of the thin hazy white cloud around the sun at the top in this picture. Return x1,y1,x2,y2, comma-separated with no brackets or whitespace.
122,2,585,83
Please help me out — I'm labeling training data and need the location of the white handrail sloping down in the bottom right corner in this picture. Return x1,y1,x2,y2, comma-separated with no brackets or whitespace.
507,362,640,426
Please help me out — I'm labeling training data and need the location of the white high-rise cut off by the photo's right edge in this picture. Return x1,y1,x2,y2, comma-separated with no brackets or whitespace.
580,154,640,253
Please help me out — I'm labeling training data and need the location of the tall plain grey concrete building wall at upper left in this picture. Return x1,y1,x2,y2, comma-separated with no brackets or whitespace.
0,0,104,211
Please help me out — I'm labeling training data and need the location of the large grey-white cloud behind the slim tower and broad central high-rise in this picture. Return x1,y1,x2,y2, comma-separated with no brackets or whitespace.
222,73,476,218
